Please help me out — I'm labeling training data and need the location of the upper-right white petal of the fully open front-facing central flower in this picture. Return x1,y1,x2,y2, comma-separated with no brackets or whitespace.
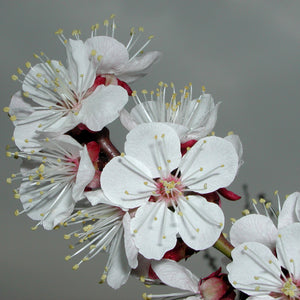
180,136,238,194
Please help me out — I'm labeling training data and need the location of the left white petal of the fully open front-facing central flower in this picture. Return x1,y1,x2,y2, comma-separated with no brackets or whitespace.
100,156,155,208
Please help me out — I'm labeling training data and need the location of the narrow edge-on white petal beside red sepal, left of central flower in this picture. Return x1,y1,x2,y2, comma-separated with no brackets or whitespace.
72,145,95,201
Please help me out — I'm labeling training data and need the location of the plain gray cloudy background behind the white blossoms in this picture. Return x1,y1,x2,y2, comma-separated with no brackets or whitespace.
0,0,300,300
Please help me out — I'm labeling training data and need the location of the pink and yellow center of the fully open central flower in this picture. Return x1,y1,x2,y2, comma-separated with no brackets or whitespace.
155,175,184,204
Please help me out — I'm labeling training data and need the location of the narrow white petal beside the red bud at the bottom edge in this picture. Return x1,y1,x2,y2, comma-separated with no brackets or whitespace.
151,259,199,293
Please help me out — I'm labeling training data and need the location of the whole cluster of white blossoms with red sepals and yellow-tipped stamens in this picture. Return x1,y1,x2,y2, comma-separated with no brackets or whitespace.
4,16,300,300
